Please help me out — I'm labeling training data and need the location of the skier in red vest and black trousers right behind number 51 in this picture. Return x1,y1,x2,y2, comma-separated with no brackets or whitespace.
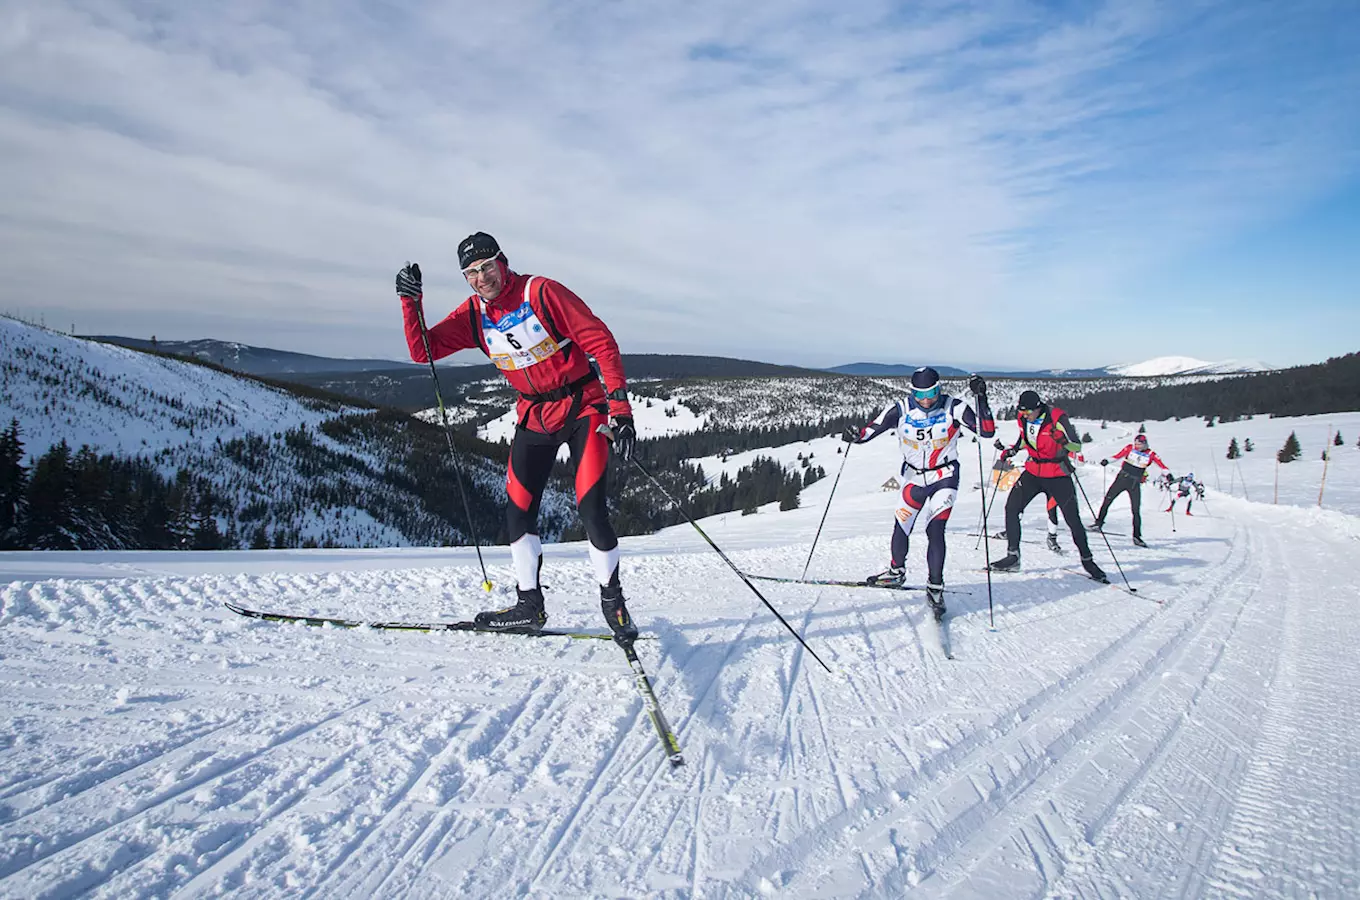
991,390,1110,583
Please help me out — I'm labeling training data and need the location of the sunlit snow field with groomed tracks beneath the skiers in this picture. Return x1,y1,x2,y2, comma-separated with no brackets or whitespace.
0,413,1360,899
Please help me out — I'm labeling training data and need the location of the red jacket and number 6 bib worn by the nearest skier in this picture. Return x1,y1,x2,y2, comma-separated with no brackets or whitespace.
401,262,632,434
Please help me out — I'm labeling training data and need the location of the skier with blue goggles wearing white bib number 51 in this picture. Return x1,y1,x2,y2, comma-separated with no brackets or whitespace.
843,366,996,621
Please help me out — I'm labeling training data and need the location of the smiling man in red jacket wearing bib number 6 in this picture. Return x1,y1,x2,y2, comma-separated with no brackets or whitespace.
397,231,638,644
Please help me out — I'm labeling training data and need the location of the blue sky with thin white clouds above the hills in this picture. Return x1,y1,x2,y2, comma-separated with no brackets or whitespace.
0,0,1360,368
